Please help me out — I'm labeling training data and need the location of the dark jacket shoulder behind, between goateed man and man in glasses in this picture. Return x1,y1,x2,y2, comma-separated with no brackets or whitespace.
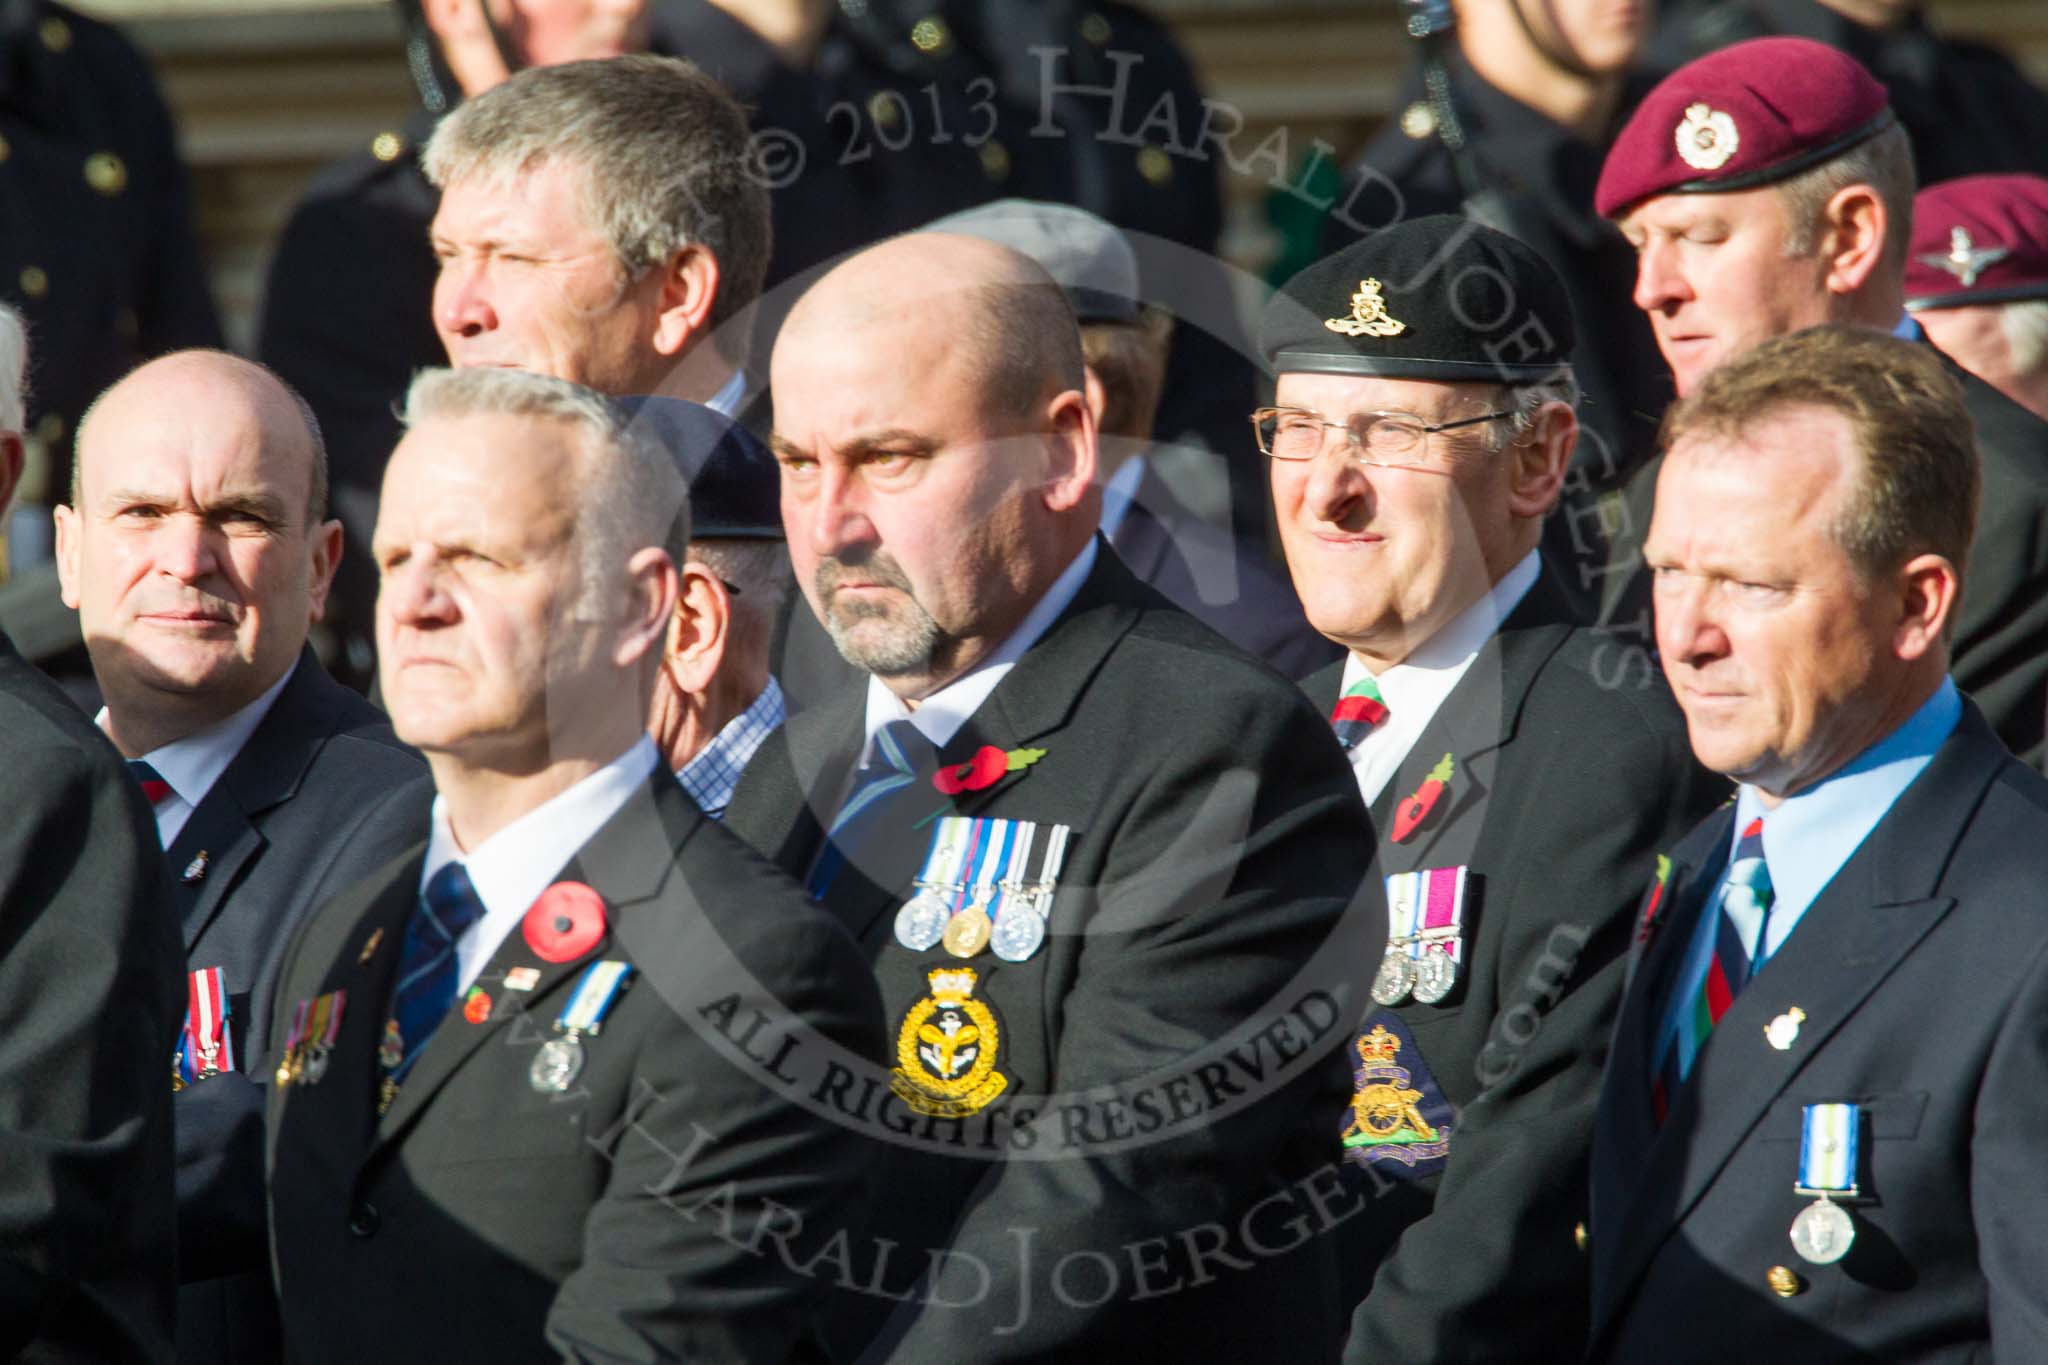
1110,467,1341,677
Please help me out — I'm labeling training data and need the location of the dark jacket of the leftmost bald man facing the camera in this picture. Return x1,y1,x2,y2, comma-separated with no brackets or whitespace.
166,651,432,1365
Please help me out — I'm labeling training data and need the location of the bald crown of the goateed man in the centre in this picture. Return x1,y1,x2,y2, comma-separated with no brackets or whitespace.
776,231,1083,422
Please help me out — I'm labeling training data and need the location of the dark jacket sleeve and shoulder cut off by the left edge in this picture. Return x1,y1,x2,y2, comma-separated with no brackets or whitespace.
0,634,184,1365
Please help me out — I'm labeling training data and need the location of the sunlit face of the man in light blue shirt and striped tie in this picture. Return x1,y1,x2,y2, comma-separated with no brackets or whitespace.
1645,407,1905,796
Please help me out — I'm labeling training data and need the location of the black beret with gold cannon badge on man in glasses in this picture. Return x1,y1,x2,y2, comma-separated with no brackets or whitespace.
1260,215,1577,383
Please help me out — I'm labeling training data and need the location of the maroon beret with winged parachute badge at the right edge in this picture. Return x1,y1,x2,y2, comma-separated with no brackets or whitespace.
1907,176,2048,309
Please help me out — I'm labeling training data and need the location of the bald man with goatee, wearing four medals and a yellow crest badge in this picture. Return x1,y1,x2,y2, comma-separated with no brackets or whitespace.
727,233,1384,1361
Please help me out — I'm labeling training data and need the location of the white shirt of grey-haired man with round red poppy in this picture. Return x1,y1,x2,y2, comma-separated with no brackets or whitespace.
420,735,662,995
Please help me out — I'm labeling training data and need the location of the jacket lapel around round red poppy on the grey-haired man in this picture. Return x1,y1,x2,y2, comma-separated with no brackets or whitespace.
373,769,705,1154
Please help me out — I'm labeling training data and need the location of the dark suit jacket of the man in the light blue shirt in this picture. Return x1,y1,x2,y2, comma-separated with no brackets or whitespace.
1591,704,2048,1365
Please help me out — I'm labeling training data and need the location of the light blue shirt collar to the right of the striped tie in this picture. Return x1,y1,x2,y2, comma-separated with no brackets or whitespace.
1729,677,1962,913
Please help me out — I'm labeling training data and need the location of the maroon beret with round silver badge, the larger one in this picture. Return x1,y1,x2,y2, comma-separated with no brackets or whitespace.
1593,39,1892,219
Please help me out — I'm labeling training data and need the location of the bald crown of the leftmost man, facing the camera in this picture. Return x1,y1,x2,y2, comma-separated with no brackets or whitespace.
72,350,328,528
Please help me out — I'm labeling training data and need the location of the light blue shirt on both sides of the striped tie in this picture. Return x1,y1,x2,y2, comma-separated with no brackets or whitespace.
1651,677,1962,1064
